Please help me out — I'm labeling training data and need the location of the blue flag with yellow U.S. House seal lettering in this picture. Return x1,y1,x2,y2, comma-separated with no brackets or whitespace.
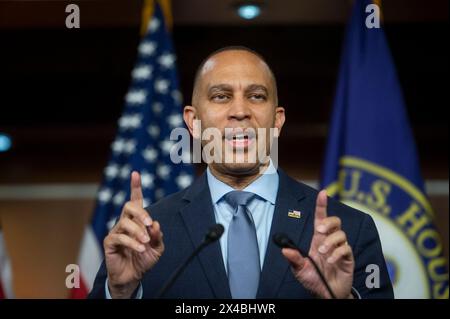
321,0,449,298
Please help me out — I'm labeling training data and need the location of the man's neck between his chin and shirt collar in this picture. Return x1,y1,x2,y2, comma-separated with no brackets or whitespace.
209,162,270,190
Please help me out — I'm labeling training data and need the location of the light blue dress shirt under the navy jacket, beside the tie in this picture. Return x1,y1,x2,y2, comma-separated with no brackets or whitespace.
206,161,279,273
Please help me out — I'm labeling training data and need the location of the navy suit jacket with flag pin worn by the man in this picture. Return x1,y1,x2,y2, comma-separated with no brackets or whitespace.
89,169,393,299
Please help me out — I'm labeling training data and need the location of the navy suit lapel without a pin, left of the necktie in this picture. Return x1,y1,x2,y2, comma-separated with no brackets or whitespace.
180,173,231,299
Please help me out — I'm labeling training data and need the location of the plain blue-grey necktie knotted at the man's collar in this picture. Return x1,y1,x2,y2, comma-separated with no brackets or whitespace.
224,191,261,299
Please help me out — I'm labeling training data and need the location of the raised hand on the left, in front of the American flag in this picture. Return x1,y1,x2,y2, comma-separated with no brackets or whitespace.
103,172,164,298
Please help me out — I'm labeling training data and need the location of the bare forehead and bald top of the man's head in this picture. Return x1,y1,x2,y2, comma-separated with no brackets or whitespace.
199,50,271,86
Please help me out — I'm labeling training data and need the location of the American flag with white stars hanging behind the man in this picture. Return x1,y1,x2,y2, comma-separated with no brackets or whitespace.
72,1,193,298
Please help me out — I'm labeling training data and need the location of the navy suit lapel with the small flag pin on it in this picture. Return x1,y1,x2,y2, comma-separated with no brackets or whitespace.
257,169,311,298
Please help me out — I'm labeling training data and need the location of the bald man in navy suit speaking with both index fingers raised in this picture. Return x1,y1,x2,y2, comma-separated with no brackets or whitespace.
90,47,393,299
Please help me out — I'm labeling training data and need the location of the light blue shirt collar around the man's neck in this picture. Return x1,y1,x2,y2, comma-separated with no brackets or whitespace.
206,160,279,204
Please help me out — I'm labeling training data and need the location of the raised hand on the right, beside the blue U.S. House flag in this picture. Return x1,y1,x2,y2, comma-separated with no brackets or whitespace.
282,190,355,298
